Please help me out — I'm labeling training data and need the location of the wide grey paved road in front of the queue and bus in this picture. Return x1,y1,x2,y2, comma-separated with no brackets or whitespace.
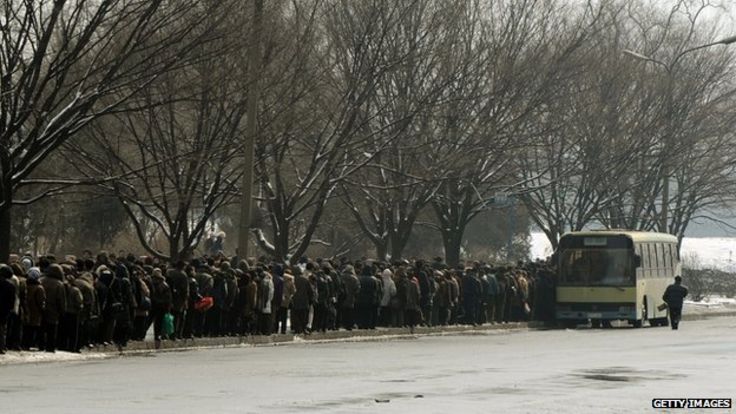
0,318,736,414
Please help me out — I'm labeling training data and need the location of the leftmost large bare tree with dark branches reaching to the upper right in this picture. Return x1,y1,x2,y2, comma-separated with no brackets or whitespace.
0,0,230,259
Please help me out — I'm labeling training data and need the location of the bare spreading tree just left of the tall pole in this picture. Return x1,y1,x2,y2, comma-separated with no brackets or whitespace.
68,19,246,261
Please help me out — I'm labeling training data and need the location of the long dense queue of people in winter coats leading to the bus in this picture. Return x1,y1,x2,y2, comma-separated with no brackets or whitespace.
0,252,555,353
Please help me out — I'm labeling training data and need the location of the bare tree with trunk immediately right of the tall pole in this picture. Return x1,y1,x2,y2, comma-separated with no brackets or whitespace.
256,0,426,259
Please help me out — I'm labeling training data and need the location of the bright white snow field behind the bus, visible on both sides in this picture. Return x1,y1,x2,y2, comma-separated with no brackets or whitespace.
530,232,736,272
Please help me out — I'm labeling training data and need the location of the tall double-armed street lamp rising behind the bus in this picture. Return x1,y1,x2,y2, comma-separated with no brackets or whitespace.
622,36,736,233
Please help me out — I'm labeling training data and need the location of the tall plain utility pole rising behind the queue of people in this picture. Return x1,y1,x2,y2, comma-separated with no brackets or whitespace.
238,0,263,260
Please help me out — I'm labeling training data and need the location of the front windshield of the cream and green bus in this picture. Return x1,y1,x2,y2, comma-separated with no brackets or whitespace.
559,248,636,286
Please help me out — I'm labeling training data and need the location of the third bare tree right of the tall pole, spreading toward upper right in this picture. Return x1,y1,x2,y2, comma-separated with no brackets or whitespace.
432,1,600,265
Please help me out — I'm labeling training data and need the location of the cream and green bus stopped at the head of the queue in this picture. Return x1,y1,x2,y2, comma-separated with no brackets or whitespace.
555,230,681,328
